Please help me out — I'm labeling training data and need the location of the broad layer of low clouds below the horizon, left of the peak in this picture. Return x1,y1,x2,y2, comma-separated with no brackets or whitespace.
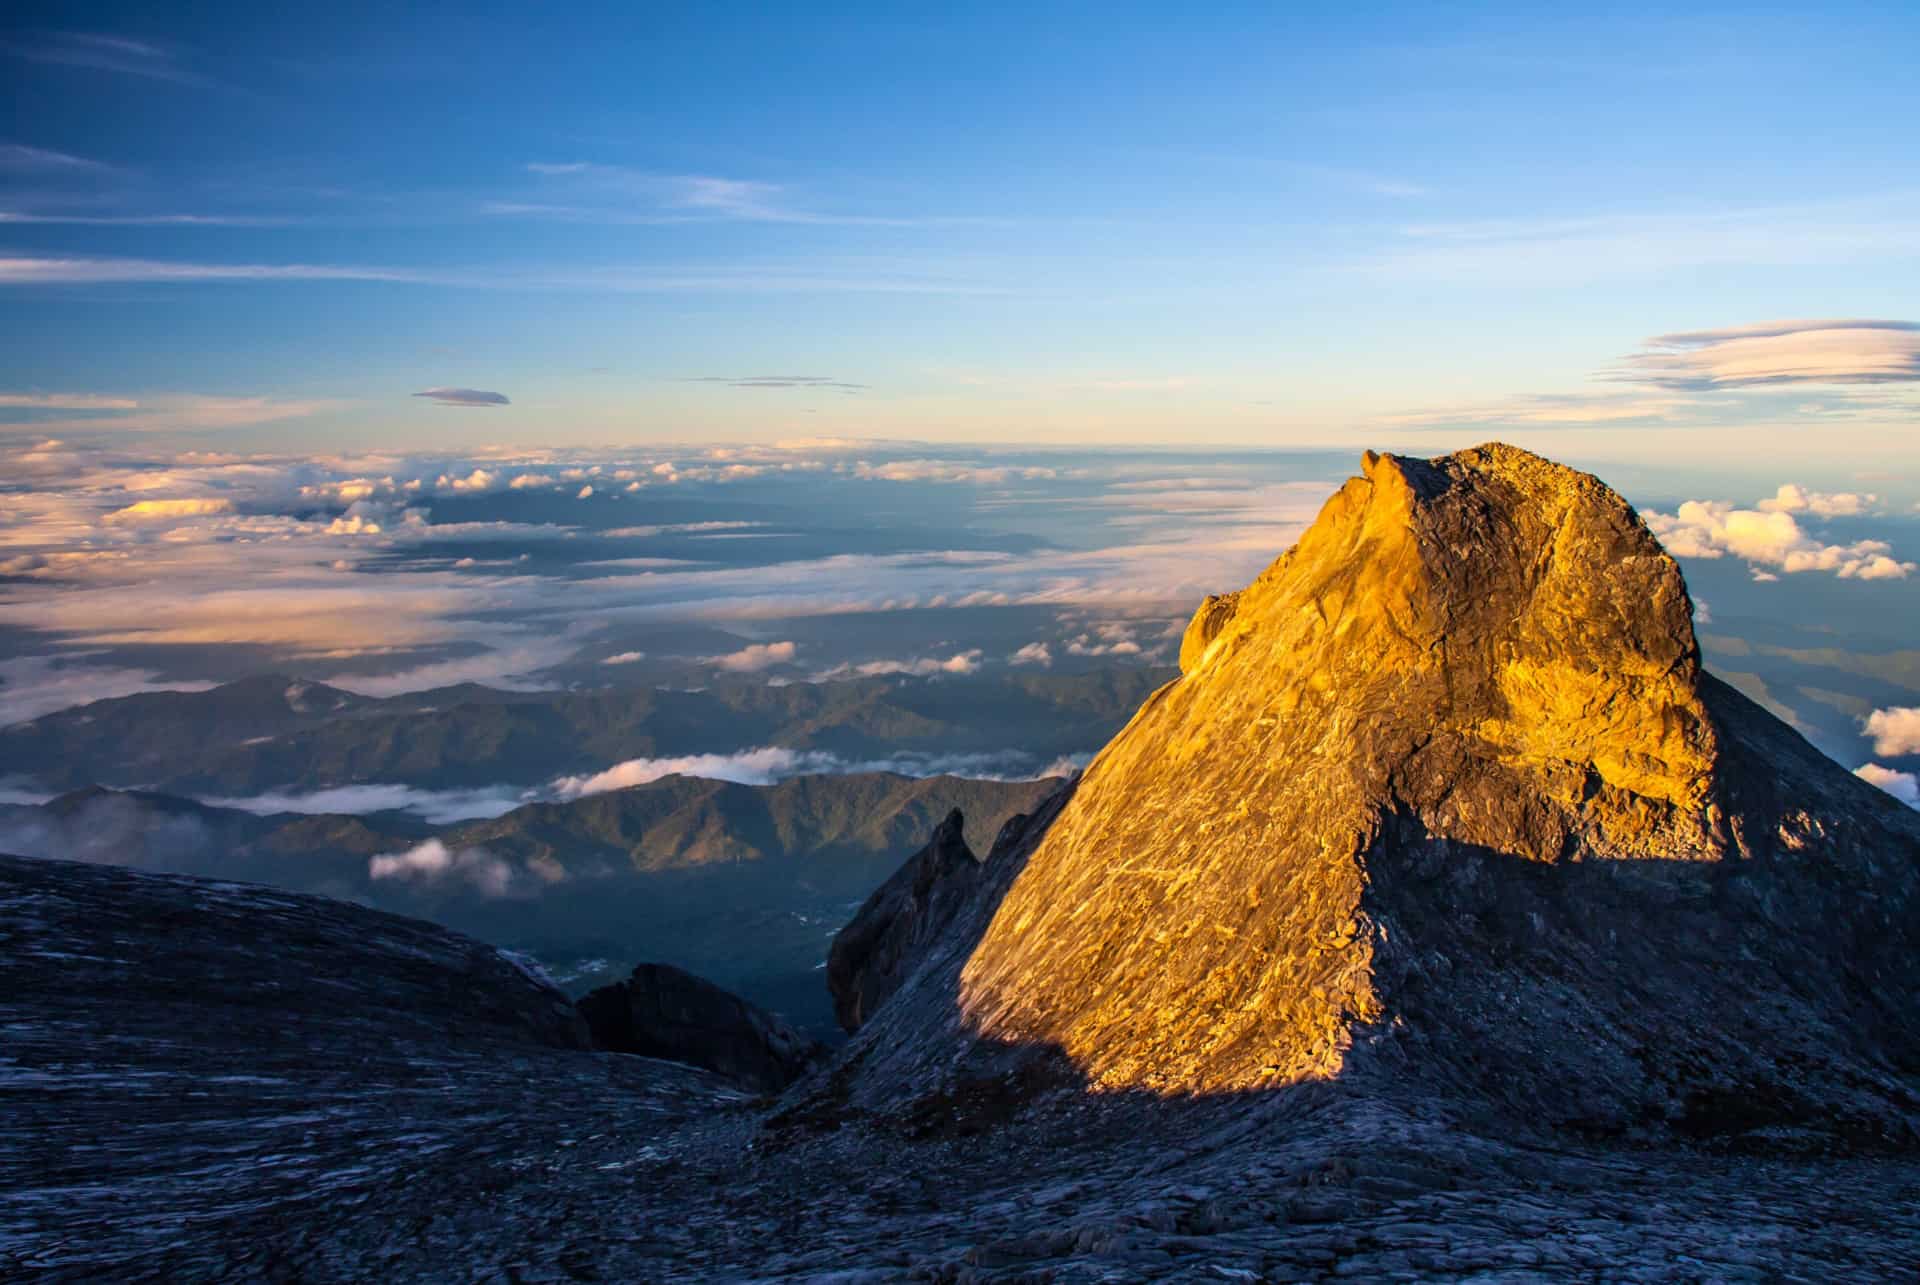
0,436,1331,722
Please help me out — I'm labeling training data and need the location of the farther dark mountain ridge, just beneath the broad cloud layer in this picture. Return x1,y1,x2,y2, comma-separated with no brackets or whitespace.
0,668,1173,797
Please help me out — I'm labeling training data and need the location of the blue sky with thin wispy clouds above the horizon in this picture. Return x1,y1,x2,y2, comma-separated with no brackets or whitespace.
0,4,1920,460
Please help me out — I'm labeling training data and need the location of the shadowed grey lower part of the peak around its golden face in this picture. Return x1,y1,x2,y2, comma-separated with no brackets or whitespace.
768,678,1920,1152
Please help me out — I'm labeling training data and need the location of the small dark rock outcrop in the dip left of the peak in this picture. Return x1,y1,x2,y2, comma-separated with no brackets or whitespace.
580,964,826,1093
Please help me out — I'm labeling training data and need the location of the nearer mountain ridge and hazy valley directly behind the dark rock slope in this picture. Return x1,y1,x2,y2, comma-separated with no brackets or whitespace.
0,772,1060,1035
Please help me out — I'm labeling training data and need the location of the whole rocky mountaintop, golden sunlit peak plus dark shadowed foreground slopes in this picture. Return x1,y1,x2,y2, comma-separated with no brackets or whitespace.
0,446,1920,1281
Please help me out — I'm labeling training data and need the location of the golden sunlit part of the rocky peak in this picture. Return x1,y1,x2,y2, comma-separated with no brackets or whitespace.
960,446,1728,1093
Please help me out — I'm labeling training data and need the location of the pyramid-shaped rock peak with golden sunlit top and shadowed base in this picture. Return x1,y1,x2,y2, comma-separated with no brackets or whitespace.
847,446,1920,1139
